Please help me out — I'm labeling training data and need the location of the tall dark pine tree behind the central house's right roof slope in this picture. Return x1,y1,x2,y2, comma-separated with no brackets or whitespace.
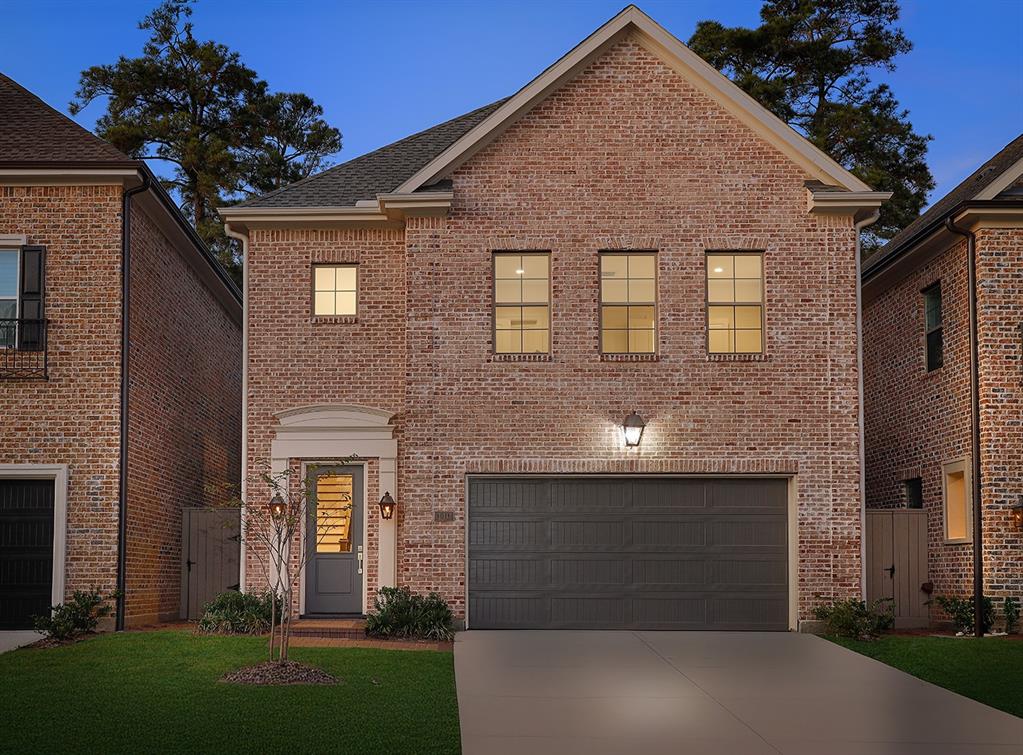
688,0,934,254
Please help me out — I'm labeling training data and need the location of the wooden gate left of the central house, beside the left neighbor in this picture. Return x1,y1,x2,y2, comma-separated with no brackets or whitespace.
181,508,241,620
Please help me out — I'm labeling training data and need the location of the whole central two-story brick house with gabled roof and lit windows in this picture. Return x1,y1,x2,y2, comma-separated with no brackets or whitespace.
225,6,888,630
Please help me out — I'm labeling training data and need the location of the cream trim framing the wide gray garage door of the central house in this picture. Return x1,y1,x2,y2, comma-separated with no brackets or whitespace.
461,472,799,632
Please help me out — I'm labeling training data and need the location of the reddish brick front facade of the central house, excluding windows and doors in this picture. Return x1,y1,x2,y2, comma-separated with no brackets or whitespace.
247,39,860,618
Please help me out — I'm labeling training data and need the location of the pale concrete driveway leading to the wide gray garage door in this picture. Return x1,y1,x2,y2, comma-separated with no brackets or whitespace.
454,631,1023,755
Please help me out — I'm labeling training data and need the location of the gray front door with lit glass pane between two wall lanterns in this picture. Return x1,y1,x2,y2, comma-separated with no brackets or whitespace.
306,467,364,614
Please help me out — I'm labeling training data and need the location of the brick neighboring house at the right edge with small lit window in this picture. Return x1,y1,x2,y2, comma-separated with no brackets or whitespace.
862,135,1023,618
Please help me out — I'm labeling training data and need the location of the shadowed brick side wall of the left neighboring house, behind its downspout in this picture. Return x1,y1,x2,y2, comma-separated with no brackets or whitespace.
126,199,241,625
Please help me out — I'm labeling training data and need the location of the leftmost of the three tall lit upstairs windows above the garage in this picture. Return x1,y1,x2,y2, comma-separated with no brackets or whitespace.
494,252,550,354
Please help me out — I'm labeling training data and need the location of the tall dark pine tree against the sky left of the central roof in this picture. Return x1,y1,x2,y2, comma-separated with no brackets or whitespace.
71,0,341,280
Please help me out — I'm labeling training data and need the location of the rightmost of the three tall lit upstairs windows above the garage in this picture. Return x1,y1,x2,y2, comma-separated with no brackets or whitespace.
707,252,764,354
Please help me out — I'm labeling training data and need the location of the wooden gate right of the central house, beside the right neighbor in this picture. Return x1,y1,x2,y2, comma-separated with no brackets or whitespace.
866,508,930,629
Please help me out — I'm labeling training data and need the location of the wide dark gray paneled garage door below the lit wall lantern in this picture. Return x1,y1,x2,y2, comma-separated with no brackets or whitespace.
469,477,788,630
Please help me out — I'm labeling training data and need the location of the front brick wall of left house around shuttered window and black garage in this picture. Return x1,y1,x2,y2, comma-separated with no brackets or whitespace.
0,186,121,593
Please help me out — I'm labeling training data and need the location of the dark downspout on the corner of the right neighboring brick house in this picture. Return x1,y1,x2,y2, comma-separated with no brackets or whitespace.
945,217,984,637
